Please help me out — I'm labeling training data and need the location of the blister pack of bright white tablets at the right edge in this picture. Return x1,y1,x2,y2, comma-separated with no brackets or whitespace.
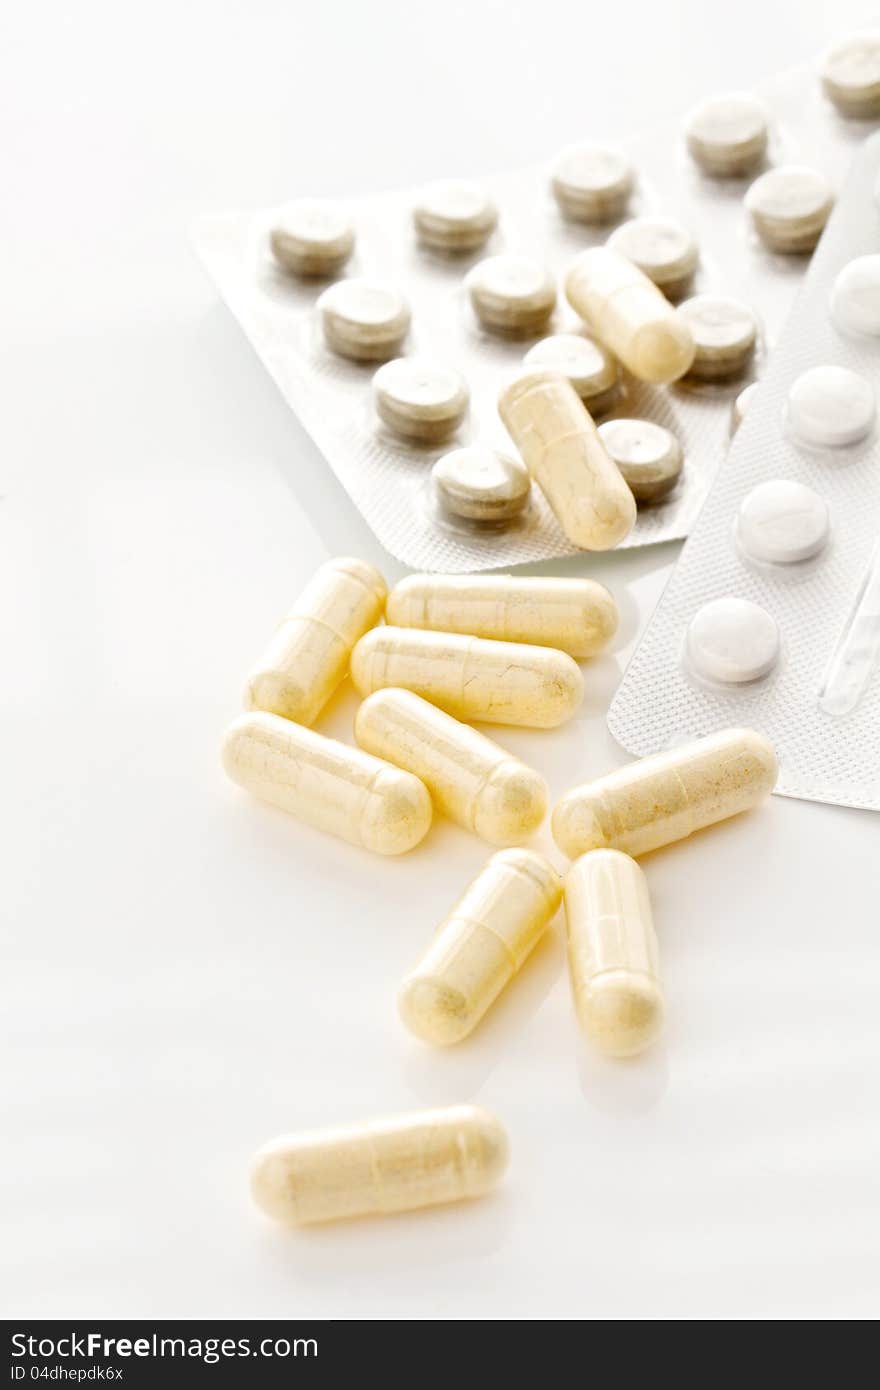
608,127,880,810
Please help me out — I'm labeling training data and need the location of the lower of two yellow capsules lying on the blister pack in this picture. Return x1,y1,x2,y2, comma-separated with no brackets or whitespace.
498,371,635,550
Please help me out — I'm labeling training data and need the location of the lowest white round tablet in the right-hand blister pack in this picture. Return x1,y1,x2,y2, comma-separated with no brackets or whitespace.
685,598,780,685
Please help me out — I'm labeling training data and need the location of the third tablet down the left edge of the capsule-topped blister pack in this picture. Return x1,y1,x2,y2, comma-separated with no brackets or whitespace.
373,357,468,443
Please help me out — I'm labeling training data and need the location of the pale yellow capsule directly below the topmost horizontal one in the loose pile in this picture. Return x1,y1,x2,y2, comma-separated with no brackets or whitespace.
352,627,584,728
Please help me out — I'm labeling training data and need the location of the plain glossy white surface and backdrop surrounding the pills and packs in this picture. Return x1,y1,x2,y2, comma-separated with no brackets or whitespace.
0,0,880,1319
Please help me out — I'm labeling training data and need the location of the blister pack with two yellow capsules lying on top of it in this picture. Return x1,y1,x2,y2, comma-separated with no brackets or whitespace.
193,55,870,571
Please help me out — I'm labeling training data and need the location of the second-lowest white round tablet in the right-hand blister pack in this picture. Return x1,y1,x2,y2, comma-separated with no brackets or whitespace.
737,478,829,564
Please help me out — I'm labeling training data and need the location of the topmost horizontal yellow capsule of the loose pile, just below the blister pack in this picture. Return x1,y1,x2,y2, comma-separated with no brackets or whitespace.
385,574,617,659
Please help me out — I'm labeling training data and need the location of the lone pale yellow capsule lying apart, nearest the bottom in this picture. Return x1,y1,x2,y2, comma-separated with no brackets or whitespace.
250,1105,509,1226
